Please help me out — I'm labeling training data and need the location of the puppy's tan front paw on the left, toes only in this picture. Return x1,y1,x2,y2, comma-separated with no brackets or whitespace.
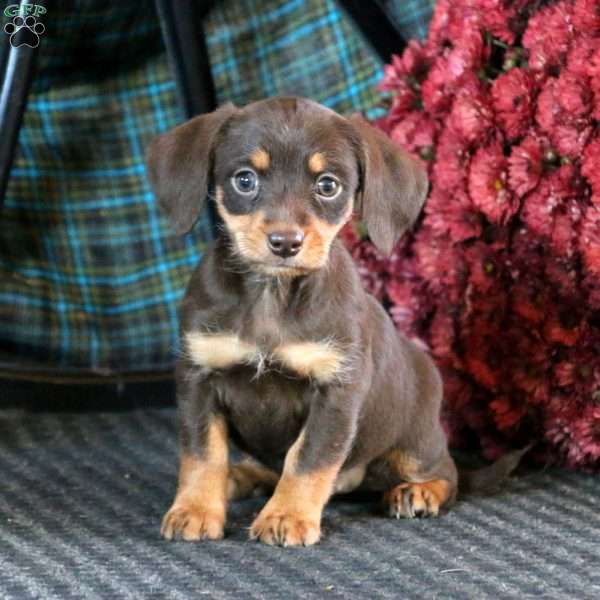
160,505,225,541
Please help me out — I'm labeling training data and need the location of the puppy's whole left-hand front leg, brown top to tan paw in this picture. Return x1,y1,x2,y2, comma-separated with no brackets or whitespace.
161,380,229,540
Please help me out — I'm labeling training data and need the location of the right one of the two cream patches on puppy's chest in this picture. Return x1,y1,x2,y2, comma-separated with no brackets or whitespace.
273,342,345,383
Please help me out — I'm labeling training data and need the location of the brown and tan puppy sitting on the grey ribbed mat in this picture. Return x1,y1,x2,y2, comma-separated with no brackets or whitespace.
148,98,457,546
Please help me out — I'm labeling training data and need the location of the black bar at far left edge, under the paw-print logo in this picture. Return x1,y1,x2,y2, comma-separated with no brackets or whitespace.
0,0,46,208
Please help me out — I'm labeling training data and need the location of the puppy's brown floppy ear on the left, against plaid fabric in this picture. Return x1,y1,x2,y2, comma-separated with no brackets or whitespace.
146,103,237,235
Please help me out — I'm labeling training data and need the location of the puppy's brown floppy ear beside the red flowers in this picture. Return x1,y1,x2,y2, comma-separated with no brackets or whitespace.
349,114,428,254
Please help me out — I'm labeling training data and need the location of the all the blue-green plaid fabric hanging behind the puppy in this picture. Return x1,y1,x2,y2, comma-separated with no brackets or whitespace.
0,0,432,373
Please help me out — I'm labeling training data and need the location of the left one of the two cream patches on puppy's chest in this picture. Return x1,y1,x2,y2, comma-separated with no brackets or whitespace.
185,331,259,369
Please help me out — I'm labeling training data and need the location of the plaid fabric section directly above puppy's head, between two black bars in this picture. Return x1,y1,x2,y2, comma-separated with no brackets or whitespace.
206,0,381,116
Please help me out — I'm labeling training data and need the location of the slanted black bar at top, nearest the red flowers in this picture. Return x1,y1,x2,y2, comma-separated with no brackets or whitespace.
338,0,406,62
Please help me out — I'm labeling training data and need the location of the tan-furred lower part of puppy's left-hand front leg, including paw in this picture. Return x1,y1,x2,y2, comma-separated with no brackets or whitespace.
160,417,228,540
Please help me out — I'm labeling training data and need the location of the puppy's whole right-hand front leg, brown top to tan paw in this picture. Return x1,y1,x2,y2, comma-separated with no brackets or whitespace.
250,388,356,546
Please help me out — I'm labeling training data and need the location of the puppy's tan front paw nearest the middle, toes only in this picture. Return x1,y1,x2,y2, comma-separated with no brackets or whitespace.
250,510,321,546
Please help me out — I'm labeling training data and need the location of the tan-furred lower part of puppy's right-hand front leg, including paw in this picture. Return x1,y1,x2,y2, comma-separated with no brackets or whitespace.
250,433,341,546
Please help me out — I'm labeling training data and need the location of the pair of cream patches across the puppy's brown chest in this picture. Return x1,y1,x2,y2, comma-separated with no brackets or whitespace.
185,331,345,383
